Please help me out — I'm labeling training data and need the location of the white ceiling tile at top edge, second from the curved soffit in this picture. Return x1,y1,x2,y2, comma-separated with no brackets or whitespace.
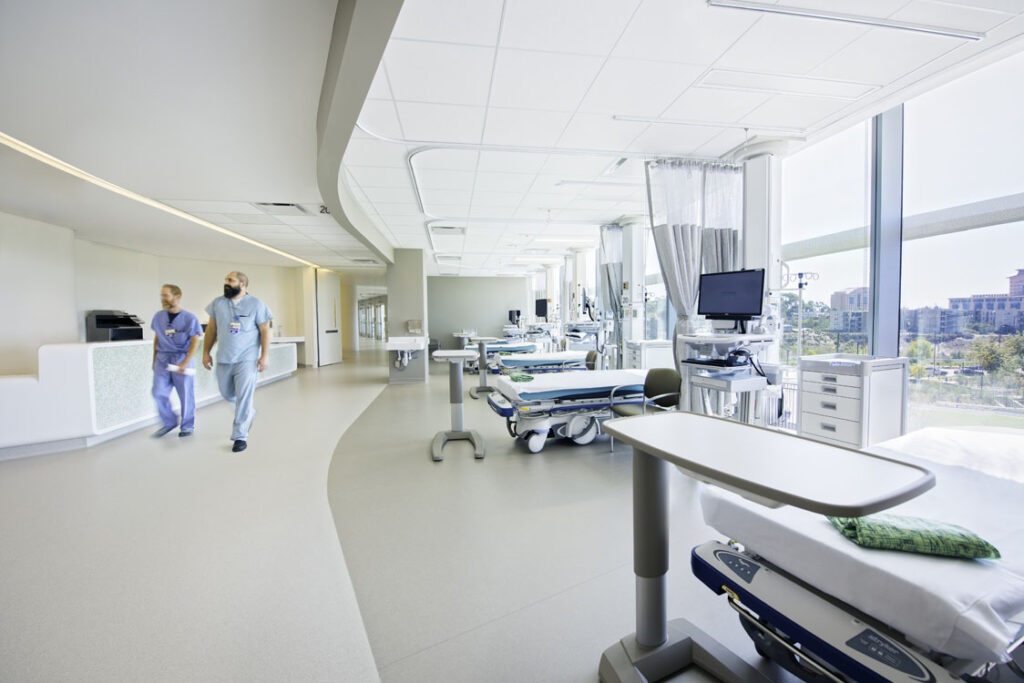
502,0,639,56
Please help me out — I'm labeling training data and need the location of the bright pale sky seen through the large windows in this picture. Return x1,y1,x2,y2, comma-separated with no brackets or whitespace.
782,54,1024,308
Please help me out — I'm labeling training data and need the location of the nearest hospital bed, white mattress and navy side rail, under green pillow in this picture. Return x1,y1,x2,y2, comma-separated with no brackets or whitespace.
691,429,1024,682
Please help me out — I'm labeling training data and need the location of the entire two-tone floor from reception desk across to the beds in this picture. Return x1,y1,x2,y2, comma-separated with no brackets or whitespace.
0,340,788,683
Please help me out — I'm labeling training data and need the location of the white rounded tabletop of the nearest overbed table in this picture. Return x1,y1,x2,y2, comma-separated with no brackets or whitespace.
603,413,935,517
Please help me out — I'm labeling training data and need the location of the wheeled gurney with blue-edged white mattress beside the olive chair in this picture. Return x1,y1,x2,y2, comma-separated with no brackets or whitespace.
487,370,646,453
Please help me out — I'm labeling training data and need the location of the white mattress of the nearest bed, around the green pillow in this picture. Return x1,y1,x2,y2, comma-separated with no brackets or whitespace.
701,429,1024,660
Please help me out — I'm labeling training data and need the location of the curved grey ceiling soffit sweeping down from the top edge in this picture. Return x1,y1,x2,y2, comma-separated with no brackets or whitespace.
316,0,402,263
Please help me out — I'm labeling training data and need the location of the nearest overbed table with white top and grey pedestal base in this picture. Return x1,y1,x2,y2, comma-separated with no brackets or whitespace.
598,413,935,683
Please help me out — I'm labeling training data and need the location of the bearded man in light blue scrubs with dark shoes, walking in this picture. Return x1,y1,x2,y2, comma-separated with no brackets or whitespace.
203,271,273,453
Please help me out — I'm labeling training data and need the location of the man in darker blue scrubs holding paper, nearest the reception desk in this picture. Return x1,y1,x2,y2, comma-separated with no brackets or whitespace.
150,285,203,437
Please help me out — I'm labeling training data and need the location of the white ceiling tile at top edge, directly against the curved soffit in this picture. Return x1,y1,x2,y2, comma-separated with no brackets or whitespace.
391,0,502,45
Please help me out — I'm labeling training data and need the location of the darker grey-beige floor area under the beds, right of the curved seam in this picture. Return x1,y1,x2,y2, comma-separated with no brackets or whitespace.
329,364,790,683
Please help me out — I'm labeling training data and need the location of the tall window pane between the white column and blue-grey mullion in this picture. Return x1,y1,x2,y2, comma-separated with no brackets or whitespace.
781,123,870,366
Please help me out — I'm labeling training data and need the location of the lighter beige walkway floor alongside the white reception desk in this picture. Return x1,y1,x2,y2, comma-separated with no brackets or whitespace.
0,353,387,683
